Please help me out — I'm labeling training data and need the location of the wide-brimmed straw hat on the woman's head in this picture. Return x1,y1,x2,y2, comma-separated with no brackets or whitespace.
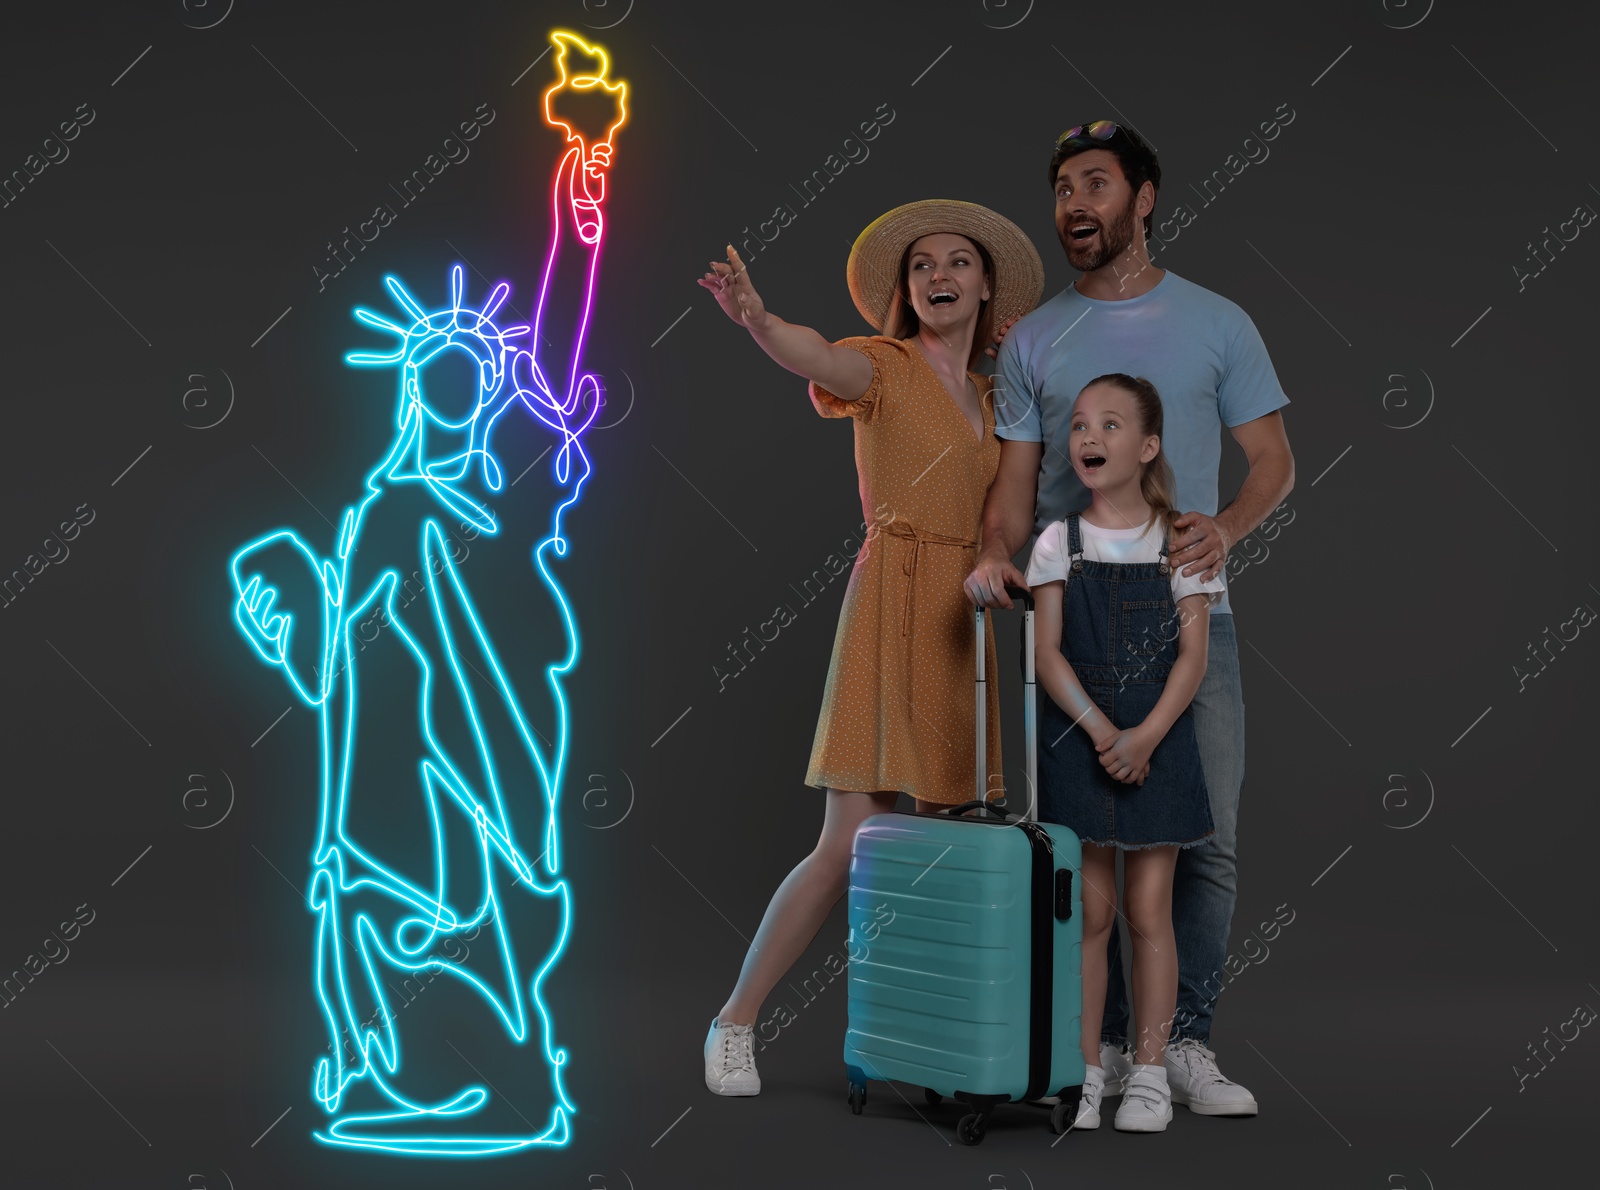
845,198,1045,331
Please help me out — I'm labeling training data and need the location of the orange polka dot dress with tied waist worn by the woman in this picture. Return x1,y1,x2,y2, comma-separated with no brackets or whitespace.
806,336,1003,803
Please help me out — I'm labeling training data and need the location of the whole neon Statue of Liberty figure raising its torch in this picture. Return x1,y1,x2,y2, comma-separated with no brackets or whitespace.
230,30,627,1156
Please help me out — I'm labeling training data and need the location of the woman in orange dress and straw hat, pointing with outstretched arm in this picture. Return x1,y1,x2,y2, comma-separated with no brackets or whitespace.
699,198,1045,1096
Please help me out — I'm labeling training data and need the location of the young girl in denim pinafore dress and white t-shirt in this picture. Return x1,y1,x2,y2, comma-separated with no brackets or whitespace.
1027,373,1222,1132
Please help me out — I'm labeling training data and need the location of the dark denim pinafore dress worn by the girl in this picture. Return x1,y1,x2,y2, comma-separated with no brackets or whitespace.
1038,513,1214,849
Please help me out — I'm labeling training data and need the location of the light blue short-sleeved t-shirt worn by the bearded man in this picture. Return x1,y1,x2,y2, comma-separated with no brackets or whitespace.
995,272,1290,614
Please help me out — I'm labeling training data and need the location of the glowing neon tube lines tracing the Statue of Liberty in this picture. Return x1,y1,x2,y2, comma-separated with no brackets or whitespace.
230,30,626,1156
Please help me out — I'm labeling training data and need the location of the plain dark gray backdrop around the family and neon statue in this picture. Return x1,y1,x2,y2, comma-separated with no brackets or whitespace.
0,0,1600,1190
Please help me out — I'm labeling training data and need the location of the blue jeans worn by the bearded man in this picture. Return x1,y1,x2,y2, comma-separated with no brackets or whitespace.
1101,616,1245,1044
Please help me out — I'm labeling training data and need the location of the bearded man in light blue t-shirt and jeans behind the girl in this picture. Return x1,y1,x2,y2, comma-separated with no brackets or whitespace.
966,120,1294,1115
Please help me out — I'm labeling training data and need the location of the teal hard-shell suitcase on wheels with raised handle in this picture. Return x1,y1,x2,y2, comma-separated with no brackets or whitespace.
845,593,1083,1145
